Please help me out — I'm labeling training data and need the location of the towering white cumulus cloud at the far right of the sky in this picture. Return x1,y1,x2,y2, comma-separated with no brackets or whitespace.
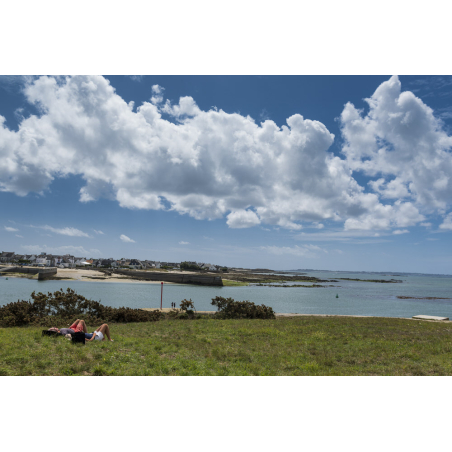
341,76,452,211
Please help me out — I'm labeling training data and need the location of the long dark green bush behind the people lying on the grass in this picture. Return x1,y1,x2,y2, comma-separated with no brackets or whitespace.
0,289,161,326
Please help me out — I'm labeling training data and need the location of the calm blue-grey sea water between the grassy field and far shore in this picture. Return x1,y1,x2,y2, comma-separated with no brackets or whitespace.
0,271,452,319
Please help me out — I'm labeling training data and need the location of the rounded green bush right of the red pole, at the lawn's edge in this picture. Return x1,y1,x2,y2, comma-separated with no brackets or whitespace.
211,297,275,319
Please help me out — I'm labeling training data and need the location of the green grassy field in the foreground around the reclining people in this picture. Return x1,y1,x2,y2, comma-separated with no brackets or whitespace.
0,317,452,375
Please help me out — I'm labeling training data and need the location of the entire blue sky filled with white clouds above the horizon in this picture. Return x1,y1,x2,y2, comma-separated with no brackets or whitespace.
0,74,452,274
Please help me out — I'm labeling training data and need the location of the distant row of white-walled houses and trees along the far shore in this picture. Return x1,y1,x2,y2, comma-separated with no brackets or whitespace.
0,251,224,271
